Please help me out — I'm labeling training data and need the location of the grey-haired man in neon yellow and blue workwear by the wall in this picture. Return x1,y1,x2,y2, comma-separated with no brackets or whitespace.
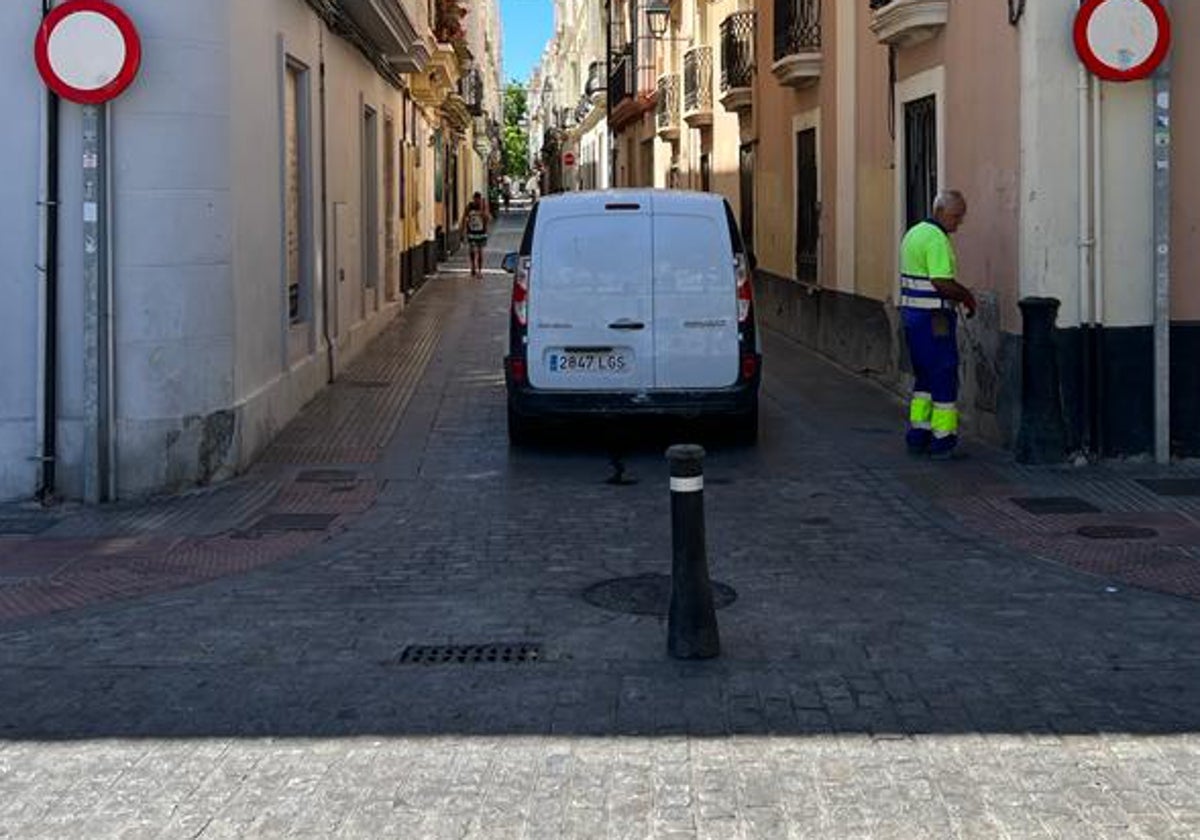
900,190,976,460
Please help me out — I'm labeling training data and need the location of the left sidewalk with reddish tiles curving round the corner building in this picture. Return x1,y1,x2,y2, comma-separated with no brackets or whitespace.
0,265,458,623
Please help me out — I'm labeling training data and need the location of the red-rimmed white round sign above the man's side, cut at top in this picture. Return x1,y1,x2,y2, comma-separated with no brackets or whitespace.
1075,0,1171,82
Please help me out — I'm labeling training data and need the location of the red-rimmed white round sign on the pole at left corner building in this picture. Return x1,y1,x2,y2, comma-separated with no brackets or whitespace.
34,0,142,104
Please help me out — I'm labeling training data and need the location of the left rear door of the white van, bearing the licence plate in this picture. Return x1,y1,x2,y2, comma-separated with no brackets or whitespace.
528,193,654,391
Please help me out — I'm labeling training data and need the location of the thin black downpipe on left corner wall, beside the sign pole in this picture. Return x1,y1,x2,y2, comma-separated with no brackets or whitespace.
37,0,59,505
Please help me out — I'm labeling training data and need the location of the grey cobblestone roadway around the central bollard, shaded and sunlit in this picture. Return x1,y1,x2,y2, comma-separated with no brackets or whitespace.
0,211,1200,840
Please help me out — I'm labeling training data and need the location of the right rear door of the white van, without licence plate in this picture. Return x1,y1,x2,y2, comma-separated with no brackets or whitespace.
654,196,739,389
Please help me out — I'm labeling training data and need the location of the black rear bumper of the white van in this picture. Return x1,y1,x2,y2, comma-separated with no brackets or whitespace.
508,377,758,418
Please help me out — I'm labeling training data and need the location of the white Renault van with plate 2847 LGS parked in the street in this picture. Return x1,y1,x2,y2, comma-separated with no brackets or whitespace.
504,190,762,444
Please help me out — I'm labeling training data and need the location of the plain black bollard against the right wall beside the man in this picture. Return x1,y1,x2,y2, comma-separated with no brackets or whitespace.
1016,298,1067,463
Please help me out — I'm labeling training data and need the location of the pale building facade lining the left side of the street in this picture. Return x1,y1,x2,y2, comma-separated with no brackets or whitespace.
0,0,498,500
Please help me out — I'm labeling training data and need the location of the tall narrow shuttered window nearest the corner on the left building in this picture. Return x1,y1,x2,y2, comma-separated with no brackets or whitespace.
283,58,312,324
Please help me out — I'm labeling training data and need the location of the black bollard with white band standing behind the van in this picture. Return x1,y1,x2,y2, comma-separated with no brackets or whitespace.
667,445,721,659
